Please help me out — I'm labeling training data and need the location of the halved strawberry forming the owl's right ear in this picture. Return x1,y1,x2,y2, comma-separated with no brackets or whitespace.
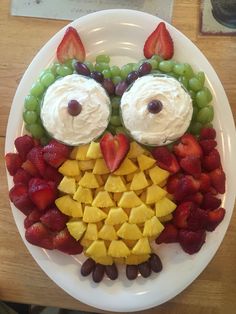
143,22,174,59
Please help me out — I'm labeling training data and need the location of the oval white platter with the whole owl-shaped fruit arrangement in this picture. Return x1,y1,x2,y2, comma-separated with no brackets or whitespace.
5,10,235,312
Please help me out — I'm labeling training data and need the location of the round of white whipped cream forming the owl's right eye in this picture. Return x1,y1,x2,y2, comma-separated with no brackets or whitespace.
120,75,193,146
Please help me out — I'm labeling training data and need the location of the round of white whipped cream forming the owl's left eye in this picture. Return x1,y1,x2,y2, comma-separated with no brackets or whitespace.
41,74,110,145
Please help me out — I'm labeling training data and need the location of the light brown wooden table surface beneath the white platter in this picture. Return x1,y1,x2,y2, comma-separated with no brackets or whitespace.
0,0,236,314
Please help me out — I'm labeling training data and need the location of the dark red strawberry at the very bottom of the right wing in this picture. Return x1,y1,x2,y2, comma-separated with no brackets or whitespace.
179,230,206,254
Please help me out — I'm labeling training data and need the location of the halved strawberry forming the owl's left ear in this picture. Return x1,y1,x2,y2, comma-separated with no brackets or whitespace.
57,26,85,63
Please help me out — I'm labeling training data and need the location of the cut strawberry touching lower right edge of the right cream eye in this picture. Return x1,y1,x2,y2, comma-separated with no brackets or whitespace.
174,133,202,158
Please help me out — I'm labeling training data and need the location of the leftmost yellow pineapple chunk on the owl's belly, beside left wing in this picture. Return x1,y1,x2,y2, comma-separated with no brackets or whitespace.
55,195,83,217
